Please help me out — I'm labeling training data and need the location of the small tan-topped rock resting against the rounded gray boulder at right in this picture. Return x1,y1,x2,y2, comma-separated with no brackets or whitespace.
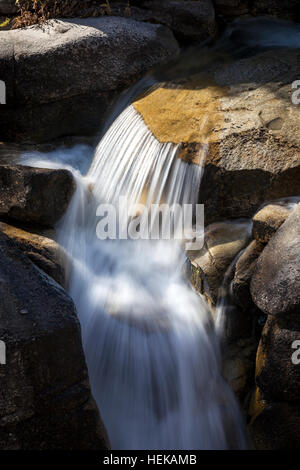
252,204,291,243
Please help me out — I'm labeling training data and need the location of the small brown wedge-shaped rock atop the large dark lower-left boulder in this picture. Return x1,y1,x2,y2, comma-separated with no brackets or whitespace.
0,222,66,286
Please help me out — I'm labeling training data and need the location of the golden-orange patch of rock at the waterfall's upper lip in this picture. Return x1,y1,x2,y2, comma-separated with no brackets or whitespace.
133,78,227,160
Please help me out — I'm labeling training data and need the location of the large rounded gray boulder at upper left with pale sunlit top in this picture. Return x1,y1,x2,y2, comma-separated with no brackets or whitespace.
7,17,179,104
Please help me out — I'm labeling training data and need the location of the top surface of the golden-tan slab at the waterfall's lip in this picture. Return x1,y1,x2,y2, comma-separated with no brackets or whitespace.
133,50,300,162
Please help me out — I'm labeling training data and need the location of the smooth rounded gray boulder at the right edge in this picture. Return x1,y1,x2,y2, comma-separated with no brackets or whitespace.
251,205,300,315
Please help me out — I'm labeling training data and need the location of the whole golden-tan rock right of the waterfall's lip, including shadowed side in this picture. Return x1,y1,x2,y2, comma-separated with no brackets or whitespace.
133,49,300,223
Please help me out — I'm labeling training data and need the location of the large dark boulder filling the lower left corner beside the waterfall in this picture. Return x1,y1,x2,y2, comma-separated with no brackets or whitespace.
0,233,108,450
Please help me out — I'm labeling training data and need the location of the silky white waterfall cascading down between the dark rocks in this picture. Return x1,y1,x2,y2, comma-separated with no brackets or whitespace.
24,107,246,449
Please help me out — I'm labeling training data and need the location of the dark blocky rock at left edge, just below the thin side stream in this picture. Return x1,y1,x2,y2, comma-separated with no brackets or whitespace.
0,165,75,226
